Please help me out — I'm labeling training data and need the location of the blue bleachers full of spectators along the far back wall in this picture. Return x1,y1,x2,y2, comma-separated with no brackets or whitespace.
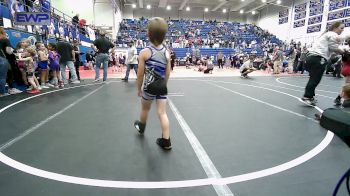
117,18,281,58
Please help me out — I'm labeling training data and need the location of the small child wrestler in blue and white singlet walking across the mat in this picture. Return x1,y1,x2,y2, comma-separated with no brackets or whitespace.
134,17,171,150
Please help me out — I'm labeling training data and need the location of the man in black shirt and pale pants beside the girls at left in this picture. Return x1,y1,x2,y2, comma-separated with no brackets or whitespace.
57,37,80,84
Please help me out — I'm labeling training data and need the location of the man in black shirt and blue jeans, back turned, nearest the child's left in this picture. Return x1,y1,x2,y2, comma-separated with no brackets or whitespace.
92,31,114,82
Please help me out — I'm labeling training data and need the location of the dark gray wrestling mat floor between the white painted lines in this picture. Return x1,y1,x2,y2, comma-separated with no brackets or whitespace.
0,77,350,196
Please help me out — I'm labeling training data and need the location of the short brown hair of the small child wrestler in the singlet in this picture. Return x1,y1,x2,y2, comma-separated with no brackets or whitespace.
148,17,168,46
